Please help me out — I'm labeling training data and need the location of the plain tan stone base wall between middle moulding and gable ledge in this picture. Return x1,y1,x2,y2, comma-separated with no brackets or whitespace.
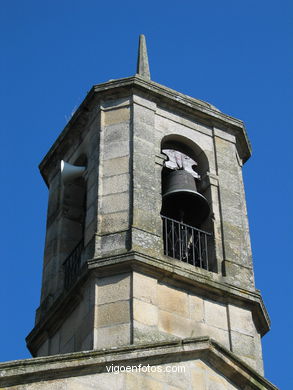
38,272,263,374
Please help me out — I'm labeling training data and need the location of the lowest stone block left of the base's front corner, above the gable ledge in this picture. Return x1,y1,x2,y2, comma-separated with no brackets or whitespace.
94,324,130,349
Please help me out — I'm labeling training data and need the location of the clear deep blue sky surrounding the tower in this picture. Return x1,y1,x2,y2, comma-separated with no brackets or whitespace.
0,0,293,390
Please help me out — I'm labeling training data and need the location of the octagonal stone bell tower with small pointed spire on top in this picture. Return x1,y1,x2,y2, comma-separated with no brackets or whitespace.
0,36,275,389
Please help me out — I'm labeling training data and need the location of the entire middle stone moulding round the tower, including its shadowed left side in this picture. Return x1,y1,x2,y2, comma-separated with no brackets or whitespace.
26,252,270,355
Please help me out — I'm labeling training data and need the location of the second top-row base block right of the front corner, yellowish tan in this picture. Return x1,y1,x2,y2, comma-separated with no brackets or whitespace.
157,284,189,318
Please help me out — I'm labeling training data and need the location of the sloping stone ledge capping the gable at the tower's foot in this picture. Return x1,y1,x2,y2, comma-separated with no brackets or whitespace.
0,337,278,390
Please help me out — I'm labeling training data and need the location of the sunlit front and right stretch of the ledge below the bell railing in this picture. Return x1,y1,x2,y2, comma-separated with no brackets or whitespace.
88,252,270,336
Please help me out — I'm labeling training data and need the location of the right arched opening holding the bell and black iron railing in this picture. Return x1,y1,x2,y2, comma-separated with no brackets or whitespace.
161,135,214,270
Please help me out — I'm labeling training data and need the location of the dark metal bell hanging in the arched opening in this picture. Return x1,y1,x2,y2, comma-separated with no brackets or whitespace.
162,170,210,227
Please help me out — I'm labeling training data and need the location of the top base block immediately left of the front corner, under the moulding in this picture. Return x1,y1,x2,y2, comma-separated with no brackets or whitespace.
97,273,130,305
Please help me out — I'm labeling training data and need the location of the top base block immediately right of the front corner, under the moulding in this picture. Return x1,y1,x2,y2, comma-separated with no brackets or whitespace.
133,272,157,305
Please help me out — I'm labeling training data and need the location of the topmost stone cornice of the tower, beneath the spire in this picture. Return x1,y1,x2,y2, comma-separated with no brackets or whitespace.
39,75,251,184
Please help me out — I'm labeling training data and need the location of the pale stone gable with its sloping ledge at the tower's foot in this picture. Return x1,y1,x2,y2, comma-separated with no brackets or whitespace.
0,338,277,390
